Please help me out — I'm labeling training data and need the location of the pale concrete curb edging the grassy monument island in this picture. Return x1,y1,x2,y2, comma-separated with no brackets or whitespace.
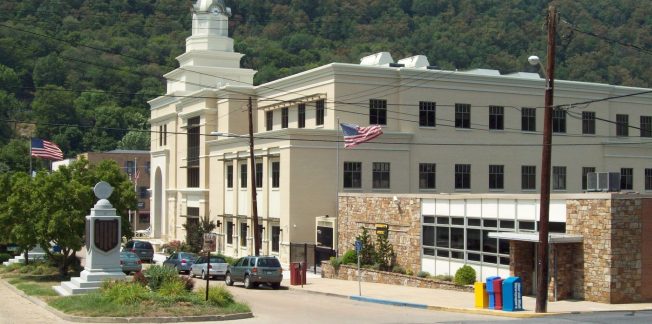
0,279,254,323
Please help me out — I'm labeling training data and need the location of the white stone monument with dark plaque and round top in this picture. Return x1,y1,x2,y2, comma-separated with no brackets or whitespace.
53,181,125,296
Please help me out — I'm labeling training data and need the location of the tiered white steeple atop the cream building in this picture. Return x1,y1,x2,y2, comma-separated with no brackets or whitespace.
164,0,256,94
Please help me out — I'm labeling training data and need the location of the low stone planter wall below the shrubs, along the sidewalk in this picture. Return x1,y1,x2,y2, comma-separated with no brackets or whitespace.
321,261,473,292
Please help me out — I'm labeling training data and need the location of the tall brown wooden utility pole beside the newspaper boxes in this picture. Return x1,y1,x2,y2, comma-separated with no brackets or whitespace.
536,5,557,313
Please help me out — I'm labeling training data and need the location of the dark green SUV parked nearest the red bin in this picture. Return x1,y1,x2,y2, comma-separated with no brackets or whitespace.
224,256,283,289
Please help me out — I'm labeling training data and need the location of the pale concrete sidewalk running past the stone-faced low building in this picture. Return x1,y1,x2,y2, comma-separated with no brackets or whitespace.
283,273,652,318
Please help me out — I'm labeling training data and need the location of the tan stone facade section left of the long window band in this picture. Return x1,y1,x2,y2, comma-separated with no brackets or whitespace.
337,194,421,273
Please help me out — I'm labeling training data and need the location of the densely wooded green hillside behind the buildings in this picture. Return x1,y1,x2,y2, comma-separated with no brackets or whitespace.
0,0,652,172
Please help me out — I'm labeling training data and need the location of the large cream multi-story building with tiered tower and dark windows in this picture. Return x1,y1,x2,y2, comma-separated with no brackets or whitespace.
150,1,652,262
